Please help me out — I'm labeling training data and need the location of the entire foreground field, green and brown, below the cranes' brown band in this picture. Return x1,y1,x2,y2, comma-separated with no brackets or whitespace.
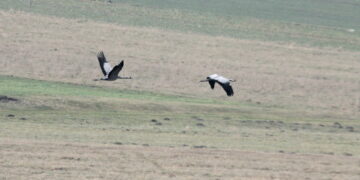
0,76,360,179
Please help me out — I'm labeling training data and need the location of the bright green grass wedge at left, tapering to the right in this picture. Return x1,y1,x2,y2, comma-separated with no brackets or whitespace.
0,76,236,105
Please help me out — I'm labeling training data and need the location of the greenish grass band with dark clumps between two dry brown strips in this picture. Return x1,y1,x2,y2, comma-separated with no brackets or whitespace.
0,76,360,156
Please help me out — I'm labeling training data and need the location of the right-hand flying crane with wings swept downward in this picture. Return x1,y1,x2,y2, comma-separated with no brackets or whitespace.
200,74,236,96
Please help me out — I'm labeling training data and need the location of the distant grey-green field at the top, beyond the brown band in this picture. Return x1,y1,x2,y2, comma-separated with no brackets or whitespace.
0,0,360,50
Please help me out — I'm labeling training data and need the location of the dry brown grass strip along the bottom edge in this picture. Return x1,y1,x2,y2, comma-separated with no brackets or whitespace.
0,138,360,179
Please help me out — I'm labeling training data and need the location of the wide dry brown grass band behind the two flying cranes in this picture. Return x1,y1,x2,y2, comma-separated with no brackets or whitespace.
0,11,360,118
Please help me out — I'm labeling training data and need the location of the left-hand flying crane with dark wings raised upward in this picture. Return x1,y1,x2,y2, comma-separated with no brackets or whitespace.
97,51,132,81
